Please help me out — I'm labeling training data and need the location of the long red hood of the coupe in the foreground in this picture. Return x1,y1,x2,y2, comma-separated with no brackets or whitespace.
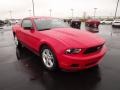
39,28,105,48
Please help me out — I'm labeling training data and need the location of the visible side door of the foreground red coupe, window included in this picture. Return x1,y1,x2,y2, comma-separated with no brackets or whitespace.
22,19,39,51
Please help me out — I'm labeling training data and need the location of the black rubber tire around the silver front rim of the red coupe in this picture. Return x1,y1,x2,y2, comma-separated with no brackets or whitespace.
40,45,58,71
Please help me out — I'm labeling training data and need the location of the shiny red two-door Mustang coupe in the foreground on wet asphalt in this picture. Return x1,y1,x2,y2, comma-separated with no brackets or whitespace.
12,17,106,70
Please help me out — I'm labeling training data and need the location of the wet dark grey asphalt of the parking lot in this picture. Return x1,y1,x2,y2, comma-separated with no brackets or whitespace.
0,24,120,90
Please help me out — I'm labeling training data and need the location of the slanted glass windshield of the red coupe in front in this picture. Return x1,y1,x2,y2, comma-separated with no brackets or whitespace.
34,18,70,30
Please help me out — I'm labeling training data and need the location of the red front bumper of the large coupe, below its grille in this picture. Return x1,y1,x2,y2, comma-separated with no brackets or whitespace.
58,46,107,70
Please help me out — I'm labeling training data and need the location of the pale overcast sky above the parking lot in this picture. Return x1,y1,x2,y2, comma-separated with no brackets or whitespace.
0,0,120,19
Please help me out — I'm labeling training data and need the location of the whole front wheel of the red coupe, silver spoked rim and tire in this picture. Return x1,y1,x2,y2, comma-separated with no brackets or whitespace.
40,46,57,71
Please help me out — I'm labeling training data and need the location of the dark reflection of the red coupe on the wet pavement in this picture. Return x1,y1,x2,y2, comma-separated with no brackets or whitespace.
16,48,101,90
